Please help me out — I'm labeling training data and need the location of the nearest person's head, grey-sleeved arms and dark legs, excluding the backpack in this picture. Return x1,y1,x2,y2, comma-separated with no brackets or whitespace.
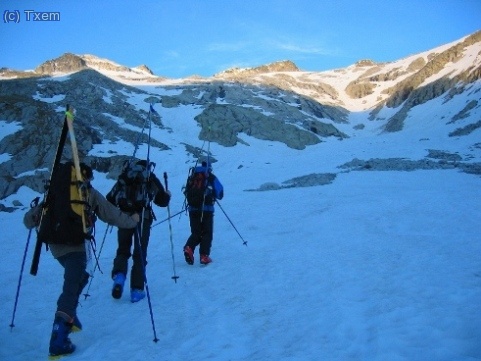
24,163,140,357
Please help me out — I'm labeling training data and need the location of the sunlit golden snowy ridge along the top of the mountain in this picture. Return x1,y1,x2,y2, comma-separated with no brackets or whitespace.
0,31,481,111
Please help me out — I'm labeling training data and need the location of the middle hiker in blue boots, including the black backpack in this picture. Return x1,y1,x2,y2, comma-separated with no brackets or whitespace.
107,160,171,303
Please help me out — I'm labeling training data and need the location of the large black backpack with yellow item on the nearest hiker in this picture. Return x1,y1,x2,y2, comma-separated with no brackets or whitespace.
38,162,94,245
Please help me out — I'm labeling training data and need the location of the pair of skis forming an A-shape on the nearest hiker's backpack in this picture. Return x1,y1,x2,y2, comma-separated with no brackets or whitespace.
30,105,93,276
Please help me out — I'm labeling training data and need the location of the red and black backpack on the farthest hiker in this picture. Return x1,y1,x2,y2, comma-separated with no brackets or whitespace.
184,168,215,208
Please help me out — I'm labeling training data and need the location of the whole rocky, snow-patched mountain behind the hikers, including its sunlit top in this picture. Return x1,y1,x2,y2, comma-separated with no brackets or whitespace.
0,31,481,199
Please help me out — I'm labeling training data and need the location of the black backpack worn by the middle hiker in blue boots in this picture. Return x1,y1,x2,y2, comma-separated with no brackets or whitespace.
106,161,153,213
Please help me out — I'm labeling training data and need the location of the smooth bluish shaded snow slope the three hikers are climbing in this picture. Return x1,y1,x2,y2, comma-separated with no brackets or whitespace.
0,94,481,361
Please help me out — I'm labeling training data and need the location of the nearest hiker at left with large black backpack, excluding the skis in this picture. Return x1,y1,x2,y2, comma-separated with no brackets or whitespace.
24,162,140,357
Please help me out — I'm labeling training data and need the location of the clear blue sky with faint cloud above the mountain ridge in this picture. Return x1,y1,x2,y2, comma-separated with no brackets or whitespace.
0,0,481,78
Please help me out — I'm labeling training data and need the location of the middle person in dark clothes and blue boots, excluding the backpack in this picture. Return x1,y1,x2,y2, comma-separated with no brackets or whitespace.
107,160,170,302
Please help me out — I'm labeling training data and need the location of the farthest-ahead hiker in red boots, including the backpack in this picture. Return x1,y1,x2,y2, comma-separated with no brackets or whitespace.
184,161,224,265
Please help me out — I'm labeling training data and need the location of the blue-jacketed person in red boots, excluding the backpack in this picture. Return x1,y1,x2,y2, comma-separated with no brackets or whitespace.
184,161,224,265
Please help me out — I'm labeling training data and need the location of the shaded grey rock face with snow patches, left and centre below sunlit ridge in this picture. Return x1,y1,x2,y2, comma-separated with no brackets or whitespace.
0,66,347,199
